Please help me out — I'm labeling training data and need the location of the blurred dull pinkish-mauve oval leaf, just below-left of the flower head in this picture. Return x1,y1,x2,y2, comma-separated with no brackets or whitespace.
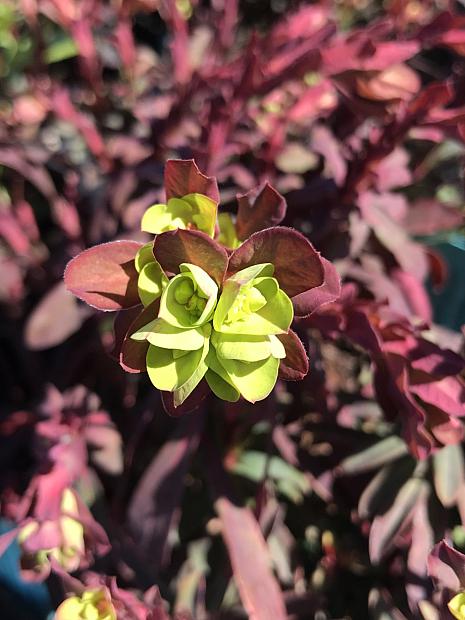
24,282,91,350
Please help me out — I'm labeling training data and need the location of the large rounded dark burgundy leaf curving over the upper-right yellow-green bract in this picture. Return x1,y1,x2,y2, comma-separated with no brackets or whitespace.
228,226,324,297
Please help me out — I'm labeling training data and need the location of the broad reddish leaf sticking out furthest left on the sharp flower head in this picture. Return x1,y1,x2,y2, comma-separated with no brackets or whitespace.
64,241,142,310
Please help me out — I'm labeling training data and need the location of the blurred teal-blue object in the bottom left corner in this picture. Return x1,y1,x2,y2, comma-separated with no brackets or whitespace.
0,521,54,620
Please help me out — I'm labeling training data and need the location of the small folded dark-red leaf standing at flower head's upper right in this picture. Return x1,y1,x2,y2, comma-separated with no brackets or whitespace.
236,183,286,239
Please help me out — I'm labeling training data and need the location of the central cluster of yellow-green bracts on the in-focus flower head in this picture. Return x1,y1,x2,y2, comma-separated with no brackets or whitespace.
131,262,293,406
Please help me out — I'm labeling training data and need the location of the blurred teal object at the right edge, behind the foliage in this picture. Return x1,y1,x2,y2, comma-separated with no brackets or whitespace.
423,233,465,331
